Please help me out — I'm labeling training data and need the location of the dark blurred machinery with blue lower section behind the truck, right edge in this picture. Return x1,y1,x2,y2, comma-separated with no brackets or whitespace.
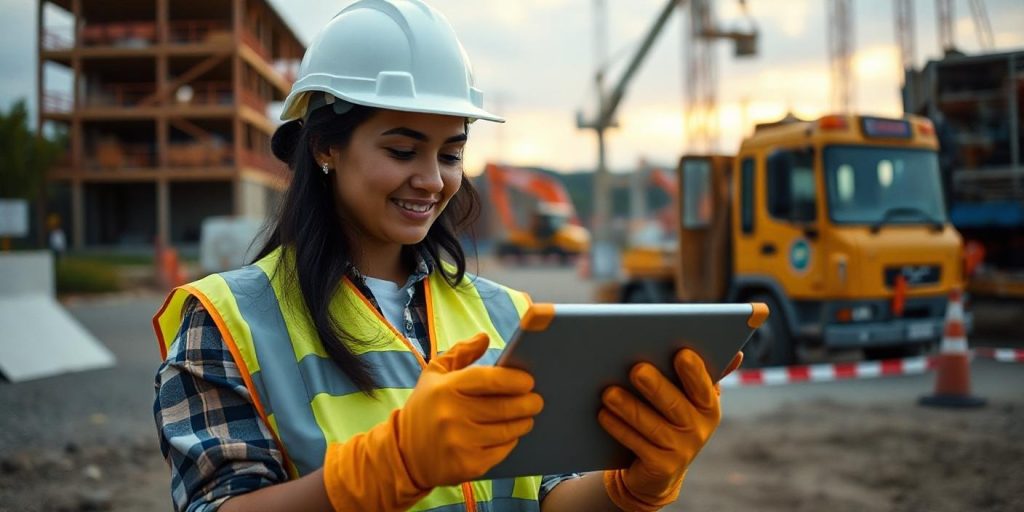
903,51,1024,300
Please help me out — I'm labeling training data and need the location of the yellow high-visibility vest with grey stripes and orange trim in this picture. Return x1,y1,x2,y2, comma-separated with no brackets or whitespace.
154,249,541,512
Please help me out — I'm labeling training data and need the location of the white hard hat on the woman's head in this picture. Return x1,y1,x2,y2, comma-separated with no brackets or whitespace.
281,0,505,122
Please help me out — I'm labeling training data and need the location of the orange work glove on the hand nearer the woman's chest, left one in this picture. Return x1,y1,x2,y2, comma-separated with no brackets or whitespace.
324,333,544,511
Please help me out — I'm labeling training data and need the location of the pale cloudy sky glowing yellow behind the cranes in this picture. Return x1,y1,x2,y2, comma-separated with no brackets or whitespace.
0,0,1024,174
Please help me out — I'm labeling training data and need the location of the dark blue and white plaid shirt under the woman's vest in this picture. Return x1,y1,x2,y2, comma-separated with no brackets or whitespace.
154,256,580,512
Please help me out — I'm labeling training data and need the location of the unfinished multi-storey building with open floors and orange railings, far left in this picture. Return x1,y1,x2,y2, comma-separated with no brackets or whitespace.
38,0,305,249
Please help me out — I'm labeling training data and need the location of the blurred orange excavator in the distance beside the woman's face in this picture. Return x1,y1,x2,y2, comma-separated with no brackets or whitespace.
481,164,590,263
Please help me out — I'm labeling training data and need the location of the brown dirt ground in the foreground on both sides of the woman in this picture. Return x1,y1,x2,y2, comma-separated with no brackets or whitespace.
0,401,1024,512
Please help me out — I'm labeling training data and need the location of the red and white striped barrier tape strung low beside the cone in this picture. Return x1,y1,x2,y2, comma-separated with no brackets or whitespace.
719,347,1024,388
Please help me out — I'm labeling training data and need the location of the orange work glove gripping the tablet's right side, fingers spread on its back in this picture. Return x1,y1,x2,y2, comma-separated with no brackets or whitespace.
597,348,743,512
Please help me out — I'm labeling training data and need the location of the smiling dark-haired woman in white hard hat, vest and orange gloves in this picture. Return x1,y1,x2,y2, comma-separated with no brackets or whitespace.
154,0,738,511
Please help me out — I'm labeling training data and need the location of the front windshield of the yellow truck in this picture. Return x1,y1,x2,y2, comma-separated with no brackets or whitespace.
824,145,946,227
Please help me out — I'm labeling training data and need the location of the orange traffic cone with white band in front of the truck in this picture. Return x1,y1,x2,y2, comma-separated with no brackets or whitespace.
920,289,985,408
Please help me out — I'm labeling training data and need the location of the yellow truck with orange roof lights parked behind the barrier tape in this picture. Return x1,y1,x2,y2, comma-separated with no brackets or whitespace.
604,115,964,366
